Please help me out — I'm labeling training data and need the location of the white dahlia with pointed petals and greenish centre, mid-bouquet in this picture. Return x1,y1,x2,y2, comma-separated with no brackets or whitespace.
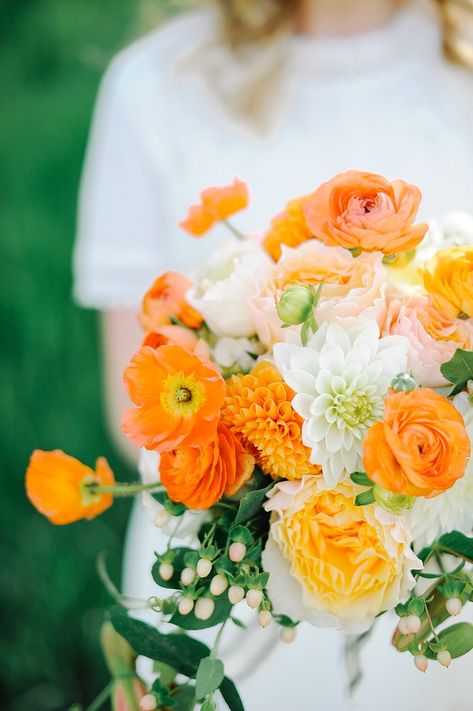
274,319,408,486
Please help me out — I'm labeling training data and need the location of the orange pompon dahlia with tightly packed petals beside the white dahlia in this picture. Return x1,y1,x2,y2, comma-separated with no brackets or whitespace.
222,361,320,479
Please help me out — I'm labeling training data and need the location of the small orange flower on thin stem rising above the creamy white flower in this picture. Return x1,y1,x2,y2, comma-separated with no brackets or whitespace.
179,178,249,237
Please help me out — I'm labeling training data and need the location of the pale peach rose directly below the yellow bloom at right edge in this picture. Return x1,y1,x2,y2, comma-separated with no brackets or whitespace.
382,296,473,388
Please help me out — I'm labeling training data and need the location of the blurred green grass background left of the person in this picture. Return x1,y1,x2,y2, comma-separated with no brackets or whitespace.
0,0,183,711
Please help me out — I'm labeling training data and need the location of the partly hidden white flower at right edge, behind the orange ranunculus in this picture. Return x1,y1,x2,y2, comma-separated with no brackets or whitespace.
406,392,473,550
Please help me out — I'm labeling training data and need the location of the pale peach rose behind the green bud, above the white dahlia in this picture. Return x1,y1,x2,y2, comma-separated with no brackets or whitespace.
250,239,386,347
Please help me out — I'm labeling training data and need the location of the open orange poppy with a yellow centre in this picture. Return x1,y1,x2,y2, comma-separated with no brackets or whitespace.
122,346,225,452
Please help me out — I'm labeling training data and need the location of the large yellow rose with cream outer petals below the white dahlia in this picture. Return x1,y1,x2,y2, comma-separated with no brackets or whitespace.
263,477,422,632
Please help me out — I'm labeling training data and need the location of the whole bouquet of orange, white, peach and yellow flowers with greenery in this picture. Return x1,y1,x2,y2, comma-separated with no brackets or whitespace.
26,171,473,711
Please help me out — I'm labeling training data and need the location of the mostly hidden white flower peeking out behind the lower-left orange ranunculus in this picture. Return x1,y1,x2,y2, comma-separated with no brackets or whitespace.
138,449,206,538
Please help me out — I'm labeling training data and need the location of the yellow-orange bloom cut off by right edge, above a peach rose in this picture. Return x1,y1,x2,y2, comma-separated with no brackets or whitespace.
423,246,473,318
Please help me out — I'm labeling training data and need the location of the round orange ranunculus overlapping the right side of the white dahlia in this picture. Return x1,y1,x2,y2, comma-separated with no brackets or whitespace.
363,388,470,498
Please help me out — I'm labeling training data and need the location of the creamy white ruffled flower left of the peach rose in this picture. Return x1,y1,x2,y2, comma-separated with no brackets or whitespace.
187,240,271,337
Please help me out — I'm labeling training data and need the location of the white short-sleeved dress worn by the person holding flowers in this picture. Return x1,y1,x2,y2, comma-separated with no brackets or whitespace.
75,1,473,711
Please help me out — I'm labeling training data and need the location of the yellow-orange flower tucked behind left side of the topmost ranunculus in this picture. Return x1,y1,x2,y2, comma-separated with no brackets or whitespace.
263,195,312,262
